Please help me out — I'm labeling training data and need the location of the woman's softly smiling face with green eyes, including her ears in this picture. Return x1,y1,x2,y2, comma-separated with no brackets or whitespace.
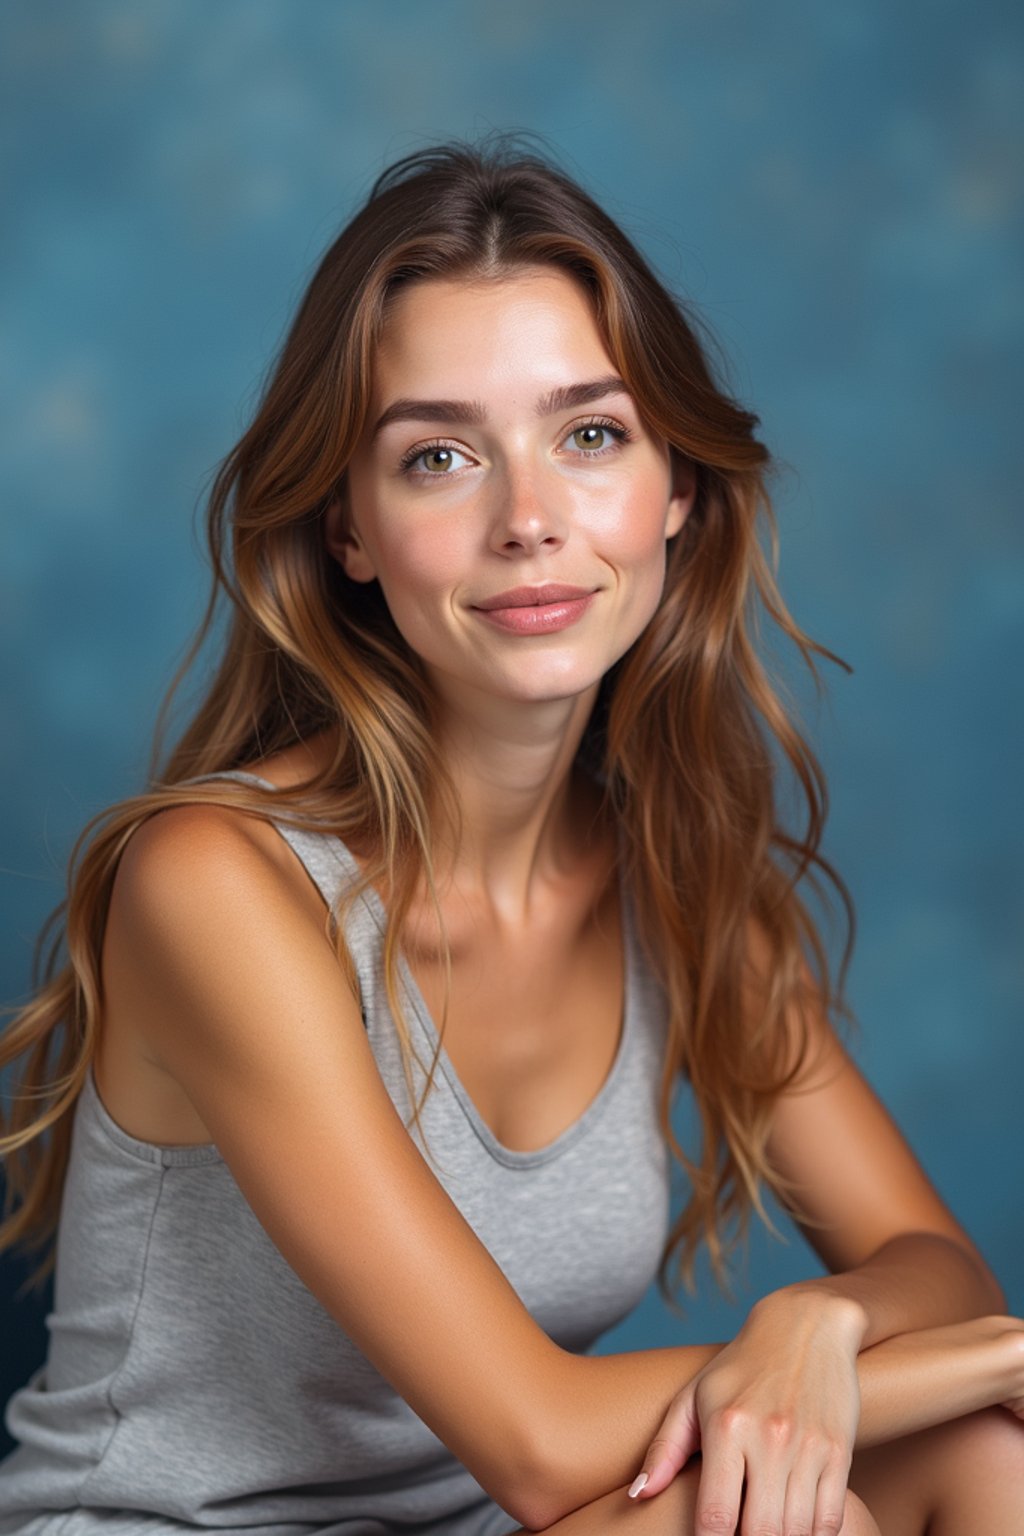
327,267,694,700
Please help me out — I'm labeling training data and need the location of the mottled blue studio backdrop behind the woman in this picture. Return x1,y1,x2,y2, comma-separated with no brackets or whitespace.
0,0,1024,1449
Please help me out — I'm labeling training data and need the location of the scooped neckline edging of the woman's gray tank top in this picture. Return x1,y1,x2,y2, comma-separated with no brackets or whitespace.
203,768,636,1169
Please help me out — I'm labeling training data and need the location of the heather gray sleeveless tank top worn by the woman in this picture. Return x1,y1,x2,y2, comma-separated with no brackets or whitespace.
0,770,669,1536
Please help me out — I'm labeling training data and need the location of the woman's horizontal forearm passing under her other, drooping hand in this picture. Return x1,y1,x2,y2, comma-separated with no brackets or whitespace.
536,1316,1024,1524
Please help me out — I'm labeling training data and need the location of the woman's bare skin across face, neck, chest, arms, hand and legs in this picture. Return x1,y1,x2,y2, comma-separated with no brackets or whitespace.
105,269,1024,1536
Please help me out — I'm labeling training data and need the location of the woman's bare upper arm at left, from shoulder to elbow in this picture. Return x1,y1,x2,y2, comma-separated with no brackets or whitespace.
112,806,577,1522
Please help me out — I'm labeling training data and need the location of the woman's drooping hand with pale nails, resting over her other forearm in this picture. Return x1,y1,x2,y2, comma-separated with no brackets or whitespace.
633,1284,866,1536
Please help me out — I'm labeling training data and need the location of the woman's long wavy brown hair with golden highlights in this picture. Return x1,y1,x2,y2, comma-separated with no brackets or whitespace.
0,135,855,1306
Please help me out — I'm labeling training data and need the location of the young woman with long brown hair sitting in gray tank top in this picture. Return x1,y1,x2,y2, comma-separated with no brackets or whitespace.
0,141,1024,1536
